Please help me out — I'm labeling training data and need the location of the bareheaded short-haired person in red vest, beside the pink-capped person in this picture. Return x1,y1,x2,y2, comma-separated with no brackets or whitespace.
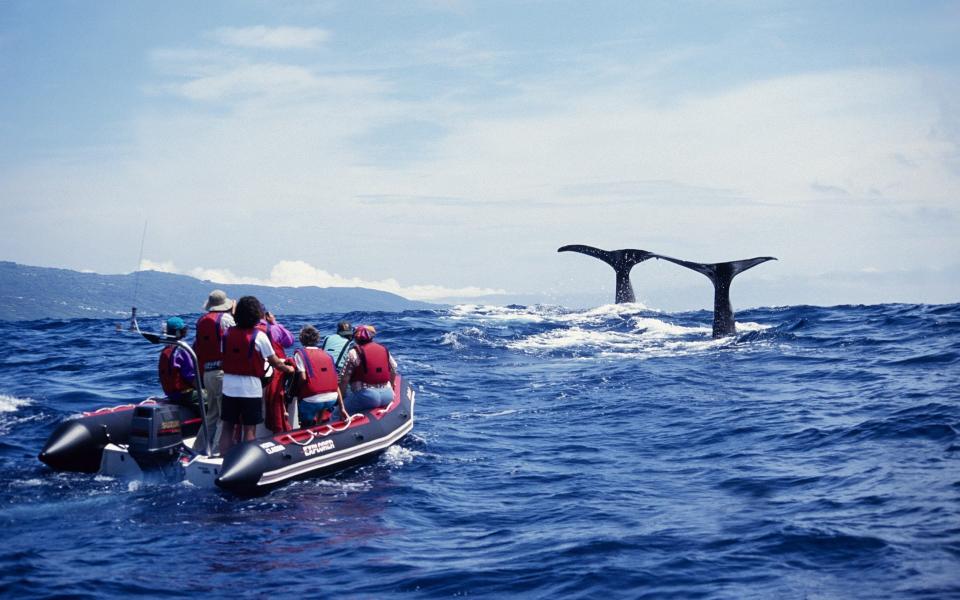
293,325,349,427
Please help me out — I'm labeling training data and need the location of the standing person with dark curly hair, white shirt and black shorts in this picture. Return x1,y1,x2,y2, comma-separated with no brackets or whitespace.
220,296,295,454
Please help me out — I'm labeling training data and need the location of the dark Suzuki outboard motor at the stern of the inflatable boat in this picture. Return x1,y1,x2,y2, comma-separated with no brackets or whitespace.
129,404,183,471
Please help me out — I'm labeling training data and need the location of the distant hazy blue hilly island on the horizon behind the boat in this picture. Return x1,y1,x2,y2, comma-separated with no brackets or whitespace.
0,261,441,321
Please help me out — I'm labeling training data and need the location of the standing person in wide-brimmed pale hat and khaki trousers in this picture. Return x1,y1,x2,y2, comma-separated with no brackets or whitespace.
193,290,236,450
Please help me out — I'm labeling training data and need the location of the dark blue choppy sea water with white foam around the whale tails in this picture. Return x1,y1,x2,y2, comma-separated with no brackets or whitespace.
0,304,960,598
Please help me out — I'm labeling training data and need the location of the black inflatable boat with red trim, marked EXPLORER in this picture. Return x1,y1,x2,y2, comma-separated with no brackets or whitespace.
39,332,416,496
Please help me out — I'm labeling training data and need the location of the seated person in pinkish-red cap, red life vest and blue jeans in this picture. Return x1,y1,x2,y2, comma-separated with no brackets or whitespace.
340,325,397,412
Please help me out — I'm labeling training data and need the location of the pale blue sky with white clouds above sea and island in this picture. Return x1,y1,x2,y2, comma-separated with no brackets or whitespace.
0,0,960,310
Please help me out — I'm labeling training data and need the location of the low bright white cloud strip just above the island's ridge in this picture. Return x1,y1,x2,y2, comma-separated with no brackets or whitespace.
141,259,507,300
